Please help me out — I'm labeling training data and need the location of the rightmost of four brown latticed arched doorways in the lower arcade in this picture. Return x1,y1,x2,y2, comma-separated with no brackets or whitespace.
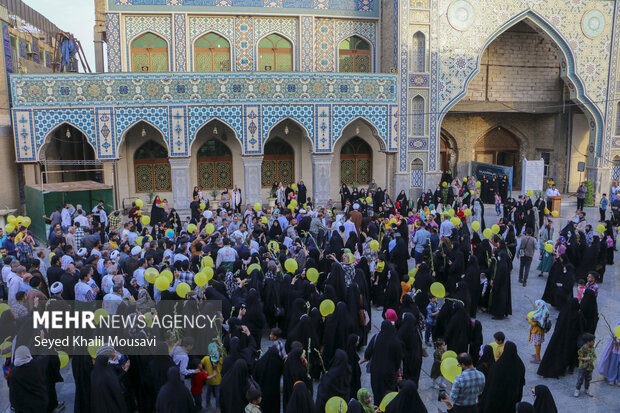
340,136,372,186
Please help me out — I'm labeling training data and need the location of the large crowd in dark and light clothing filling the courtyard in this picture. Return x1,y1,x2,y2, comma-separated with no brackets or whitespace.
0,172,620,413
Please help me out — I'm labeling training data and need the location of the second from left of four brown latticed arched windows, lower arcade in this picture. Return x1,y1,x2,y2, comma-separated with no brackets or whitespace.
198,139,233,189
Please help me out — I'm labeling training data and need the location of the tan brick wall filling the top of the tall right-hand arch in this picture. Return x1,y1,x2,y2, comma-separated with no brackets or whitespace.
466,26,563,102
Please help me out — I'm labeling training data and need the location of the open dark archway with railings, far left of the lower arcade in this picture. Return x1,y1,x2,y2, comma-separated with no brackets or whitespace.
40,124,98,183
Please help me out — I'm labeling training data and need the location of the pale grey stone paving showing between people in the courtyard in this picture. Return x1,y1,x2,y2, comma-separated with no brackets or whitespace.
0,199,620,413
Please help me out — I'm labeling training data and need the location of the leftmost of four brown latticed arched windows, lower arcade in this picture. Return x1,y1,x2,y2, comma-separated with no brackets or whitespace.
134,141,172,192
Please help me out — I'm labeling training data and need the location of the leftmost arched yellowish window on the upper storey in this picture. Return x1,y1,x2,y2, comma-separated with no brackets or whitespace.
131,33,168,72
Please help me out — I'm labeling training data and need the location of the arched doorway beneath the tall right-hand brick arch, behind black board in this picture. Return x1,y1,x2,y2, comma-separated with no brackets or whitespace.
475,126,521,185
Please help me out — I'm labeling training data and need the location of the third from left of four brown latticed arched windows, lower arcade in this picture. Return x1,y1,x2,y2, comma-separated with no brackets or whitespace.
261,138,295,188
